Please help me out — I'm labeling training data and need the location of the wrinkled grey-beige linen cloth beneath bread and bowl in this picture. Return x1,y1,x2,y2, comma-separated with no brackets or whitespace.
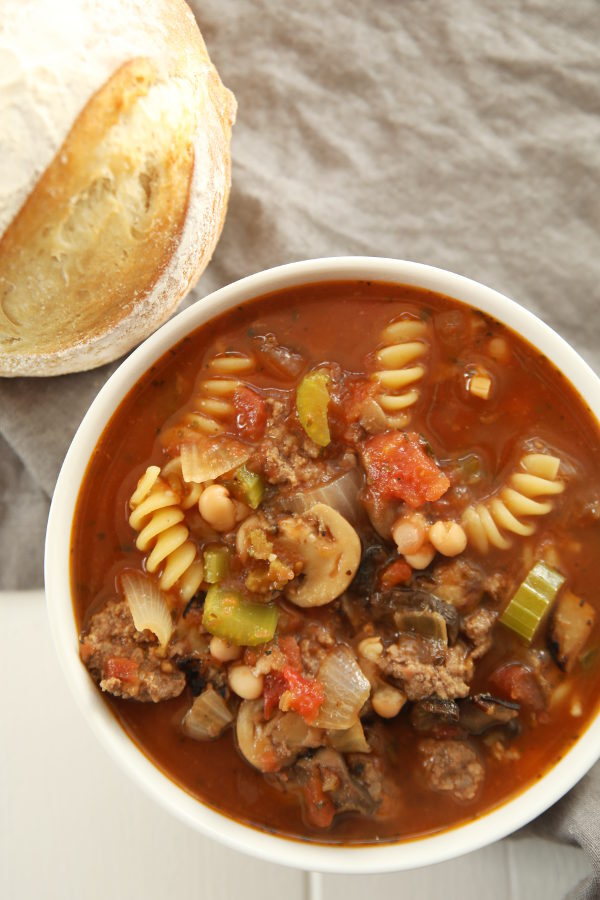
0,0,600,898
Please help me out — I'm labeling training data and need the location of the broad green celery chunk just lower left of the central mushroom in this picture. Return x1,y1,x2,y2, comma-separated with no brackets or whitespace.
202,584,278,647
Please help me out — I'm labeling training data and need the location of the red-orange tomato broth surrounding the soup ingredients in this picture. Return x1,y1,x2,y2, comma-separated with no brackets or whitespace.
71,282,600,843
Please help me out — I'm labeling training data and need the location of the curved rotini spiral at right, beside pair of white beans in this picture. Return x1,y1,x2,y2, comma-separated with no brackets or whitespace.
461,453,565,553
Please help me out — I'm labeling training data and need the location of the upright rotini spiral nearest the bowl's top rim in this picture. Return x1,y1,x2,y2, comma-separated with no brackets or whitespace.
372,319,427,429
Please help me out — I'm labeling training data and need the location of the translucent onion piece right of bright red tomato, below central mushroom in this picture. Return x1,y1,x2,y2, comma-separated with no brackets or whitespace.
315,646,371,731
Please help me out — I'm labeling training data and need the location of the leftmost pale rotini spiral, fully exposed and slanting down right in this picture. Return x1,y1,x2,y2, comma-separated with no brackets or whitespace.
129,466,204,601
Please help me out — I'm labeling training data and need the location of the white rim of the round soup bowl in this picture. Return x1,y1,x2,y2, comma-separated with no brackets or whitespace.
45,257,600,874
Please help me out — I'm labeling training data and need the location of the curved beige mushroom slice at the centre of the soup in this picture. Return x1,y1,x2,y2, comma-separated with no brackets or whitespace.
279,503,361,607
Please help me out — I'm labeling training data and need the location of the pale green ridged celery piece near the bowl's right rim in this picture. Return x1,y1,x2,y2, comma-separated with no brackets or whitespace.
500,562,565,643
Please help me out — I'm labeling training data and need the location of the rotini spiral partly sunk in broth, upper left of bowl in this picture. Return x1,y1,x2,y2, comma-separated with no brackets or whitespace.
161,352,256,444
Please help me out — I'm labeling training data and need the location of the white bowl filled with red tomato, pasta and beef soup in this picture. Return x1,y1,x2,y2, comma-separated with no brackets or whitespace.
46,257,600,873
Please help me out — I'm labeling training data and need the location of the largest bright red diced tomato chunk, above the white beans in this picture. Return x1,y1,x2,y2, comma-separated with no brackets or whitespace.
362,431,450,509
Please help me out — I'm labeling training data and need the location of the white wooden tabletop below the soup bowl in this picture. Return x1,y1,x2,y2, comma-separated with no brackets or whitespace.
0,591,588,900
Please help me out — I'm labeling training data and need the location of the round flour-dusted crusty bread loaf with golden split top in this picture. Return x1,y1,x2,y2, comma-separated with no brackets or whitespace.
0,0,235,375
